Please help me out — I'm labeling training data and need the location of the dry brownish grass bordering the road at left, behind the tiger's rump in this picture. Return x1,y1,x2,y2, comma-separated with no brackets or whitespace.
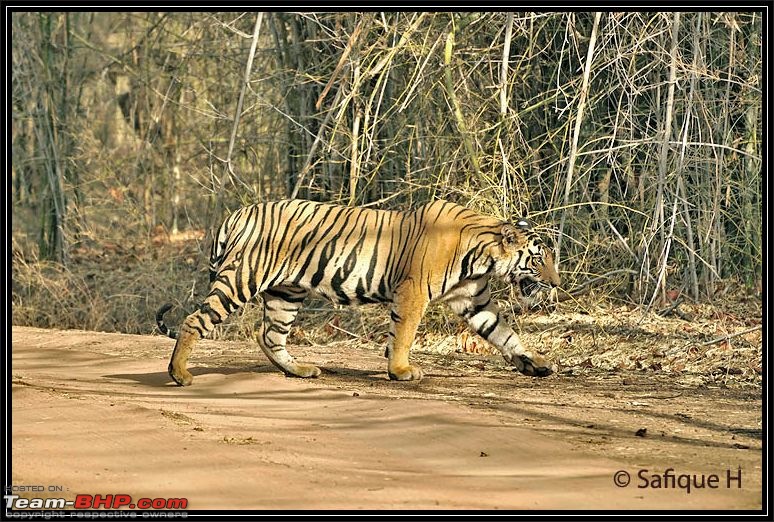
11,234,207,334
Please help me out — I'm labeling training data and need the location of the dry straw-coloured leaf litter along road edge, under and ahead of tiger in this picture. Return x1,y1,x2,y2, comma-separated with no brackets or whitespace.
334,293,763,386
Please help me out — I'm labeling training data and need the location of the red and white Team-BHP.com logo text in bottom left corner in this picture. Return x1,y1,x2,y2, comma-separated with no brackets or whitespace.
3,494,188,509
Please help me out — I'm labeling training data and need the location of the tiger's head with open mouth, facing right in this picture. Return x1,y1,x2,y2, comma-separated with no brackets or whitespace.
494,219,562,306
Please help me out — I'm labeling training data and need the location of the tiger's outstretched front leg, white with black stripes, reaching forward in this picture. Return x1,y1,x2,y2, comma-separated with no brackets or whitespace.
446,278,557,377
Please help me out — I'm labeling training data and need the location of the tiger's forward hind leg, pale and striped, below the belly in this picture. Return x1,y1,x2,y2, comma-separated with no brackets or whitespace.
258,286,320,377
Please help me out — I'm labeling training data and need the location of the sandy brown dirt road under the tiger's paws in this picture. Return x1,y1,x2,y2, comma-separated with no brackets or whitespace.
12,327,762,509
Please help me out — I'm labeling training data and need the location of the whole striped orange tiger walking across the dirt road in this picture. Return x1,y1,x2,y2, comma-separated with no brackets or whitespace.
156,199,561,386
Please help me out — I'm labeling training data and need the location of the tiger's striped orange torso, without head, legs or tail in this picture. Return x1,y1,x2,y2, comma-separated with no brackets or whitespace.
210,200,499,305
